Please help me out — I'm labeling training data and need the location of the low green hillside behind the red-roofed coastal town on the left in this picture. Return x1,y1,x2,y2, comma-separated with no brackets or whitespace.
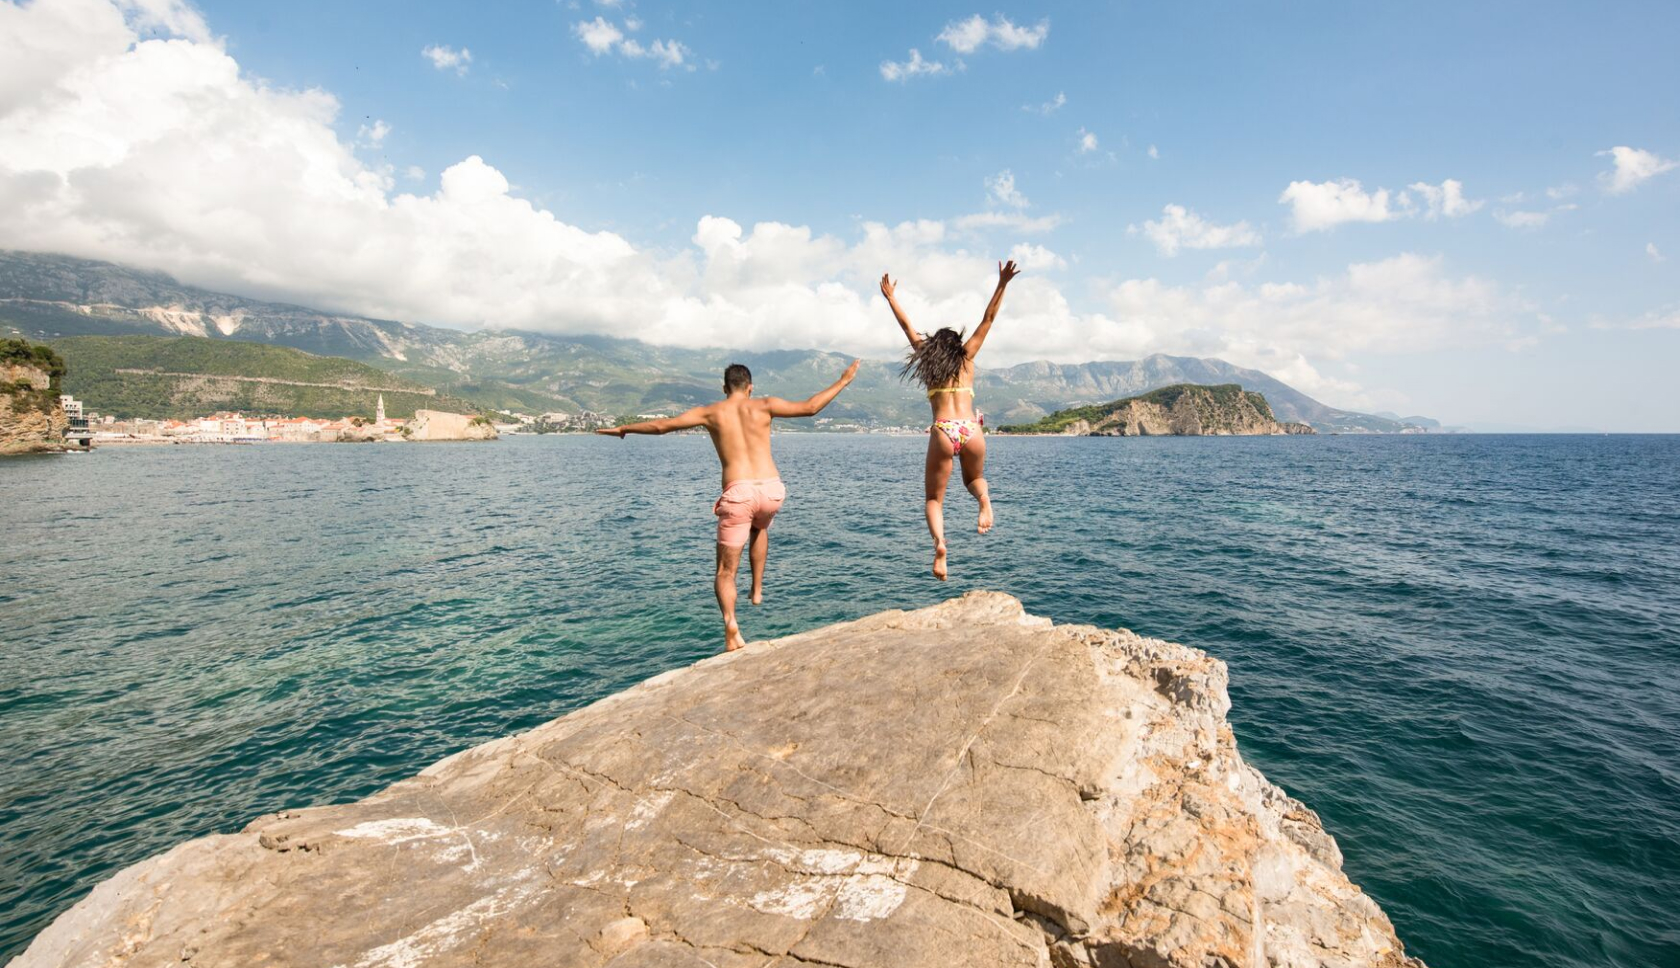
52,336,479,420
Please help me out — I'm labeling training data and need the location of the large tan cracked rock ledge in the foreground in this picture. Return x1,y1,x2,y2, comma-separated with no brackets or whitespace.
13,592,1421,968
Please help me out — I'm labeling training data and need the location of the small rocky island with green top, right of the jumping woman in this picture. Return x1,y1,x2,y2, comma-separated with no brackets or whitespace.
998,383,1315,437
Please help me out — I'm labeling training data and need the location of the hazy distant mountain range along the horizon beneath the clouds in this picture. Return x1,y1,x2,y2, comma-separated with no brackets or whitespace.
0,250,1423,434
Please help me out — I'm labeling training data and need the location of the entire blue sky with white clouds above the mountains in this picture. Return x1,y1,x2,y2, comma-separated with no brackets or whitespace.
0,0,1680,432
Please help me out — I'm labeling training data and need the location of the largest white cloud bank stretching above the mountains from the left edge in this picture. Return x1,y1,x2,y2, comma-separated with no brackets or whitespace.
0,0,1545,405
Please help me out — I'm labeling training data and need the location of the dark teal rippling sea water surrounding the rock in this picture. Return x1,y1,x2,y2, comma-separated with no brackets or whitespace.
0,435,1680,968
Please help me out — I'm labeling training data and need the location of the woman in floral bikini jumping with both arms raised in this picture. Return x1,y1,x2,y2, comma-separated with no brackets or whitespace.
880,260,1020,581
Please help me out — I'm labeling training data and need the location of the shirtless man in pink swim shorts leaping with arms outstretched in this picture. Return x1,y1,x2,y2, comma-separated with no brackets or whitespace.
596,360,857,652
